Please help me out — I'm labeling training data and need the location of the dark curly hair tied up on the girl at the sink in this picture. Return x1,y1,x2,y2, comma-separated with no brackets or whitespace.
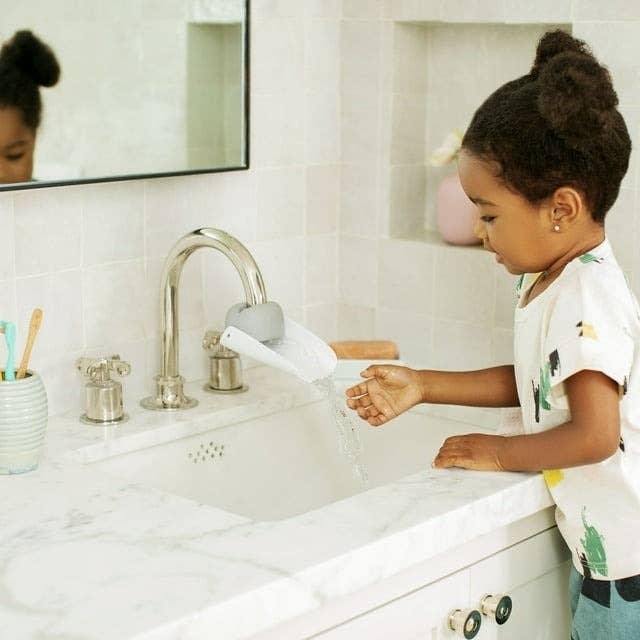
462,30,631,223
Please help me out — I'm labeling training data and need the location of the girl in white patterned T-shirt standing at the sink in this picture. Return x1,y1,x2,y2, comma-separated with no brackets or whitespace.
346,31,640,640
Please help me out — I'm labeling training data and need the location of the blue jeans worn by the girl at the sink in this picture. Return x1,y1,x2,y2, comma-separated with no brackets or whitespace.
569,566,640,640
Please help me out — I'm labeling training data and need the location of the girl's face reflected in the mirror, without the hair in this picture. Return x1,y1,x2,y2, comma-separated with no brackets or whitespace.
0,107,35,184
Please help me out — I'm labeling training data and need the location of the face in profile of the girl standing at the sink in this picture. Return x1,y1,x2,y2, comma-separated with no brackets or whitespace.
458,150,557,274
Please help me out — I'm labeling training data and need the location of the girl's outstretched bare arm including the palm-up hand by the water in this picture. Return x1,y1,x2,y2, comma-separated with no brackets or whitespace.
346,365,520,427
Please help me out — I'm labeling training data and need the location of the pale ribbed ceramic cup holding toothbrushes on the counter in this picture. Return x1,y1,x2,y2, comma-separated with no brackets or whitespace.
0,370,47,475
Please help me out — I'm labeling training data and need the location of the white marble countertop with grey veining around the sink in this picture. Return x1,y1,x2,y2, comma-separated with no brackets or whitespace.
0,367,552,640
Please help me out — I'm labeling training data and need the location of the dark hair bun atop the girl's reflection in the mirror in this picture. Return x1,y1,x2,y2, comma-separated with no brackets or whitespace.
0,31,60,87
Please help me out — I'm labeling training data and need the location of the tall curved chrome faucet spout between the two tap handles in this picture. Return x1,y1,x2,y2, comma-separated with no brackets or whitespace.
140,228,283,410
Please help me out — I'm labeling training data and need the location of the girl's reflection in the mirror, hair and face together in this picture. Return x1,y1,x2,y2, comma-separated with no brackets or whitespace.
0,31,60,184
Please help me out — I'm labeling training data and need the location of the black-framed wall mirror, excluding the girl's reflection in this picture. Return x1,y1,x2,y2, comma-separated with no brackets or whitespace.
0,0,248,190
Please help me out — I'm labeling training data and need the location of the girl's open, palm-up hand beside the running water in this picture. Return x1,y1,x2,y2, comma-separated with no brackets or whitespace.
345,365,422,427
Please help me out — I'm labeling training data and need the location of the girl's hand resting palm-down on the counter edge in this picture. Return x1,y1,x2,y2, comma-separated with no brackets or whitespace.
433,433,504,471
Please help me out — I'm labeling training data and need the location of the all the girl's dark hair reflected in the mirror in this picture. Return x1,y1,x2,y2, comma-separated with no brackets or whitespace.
0,31,60,132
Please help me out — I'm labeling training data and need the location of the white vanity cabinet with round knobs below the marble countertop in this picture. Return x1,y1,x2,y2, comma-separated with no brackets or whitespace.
307,526,570,640
